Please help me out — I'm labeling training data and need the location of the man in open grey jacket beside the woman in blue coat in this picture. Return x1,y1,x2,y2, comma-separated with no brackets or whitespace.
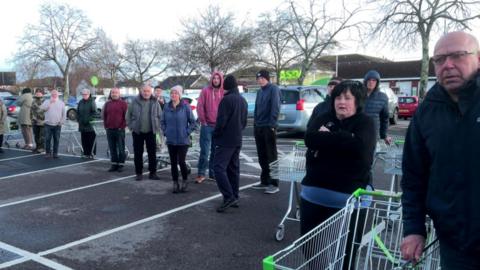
126,84,162,181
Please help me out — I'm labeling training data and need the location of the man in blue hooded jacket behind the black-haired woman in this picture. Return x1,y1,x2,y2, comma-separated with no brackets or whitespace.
363,70,392,144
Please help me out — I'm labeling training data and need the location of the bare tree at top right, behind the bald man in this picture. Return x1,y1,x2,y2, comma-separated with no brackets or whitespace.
373,0,480,97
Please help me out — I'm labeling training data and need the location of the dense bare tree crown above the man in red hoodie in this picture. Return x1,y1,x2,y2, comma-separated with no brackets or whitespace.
178,6,252,73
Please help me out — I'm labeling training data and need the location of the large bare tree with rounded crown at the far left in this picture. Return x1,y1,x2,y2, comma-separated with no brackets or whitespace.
16,4,97,100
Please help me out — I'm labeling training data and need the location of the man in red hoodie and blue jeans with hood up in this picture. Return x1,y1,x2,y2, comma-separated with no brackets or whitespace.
195,71,224,184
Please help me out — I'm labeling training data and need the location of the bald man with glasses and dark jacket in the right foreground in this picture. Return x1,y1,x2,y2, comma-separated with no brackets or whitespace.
401,32,480,270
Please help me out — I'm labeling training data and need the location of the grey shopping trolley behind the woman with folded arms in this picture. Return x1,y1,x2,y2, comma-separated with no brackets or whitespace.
270,142,306,241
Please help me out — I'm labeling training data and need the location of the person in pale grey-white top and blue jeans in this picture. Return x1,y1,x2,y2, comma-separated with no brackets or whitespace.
40,90,66,158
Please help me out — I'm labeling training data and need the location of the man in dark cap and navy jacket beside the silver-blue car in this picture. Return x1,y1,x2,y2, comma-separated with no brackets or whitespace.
252,70,280,194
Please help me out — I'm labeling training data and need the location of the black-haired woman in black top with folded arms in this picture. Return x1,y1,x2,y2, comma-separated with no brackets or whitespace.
300,80,376,269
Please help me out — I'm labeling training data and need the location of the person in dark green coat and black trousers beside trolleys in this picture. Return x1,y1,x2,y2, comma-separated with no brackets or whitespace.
77,89,97,159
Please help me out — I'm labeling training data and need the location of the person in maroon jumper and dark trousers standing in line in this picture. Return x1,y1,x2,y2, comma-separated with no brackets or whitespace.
102,88,128,172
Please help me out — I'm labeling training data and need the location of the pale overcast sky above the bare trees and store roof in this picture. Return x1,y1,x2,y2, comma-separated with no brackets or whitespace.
0,0,479,71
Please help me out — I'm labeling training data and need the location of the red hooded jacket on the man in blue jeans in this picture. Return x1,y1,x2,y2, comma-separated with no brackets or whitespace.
197,71,224,127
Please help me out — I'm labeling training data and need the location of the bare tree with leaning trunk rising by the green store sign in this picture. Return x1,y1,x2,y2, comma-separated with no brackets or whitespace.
284,0,362,85
